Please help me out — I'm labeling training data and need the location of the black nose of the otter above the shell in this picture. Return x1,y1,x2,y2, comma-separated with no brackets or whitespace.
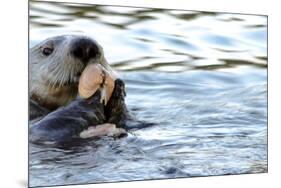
71,38,100,64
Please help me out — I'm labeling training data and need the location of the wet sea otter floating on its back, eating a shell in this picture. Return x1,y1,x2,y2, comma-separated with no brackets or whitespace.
29,35,152,144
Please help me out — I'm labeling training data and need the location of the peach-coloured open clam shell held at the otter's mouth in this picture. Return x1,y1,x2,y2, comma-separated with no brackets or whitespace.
78,63,114,104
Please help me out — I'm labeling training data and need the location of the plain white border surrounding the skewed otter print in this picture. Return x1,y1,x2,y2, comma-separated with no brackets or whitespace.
0,0,281,188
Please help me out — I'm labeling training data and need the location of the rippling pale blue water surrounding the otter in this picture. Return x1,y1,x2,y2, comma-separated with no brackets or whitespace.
29,2,267,186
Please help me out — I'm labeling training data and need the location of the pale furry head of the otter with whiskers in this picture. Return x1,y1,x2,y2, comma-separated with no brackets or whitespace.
29,35,115,110
